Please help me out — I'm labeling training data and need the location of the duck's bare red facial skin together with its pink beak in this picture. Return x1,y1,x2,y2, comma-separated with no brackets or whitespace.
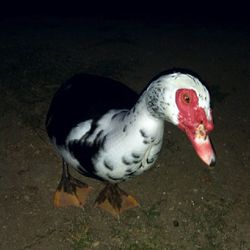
176,89,215,165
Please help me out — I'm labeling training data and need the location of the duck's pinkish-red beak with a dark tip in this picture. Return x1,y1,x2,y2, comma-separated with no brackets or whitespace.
186,123,215,166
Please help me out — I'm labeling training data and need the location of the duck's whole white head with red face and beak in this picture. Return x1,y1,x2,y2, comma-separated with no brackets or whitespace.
146,73,215,166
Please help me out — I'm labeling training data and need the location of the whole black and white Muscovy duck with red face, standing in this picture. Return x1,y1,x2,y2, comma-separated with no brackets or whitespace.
45,70,216,217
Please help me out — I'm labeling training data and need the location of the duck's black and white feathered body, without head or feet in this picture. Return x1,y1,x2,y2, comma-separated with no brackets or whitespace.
46,75,164,182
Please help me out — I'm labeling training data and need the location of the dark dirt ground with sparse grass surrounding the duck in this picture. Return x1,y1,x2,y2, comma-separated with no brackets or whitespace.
0,18,250,250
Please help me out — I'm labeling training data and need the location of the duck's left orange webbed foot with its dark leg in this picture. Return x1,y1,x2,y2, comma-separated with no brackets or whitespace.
54,160,92,207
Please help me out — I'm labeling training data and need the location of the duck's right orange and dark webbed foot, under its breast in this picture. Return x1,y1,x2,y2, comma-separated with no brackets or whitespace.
95,183,139,217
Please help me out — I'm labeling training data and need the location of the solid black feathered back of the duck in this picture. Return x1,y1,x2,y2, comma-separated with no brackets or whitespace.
46,74,138,145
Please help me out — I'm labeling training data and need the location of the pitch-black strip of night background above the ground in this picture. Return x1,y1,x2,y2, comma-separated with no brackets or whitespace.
0,1,249,25
